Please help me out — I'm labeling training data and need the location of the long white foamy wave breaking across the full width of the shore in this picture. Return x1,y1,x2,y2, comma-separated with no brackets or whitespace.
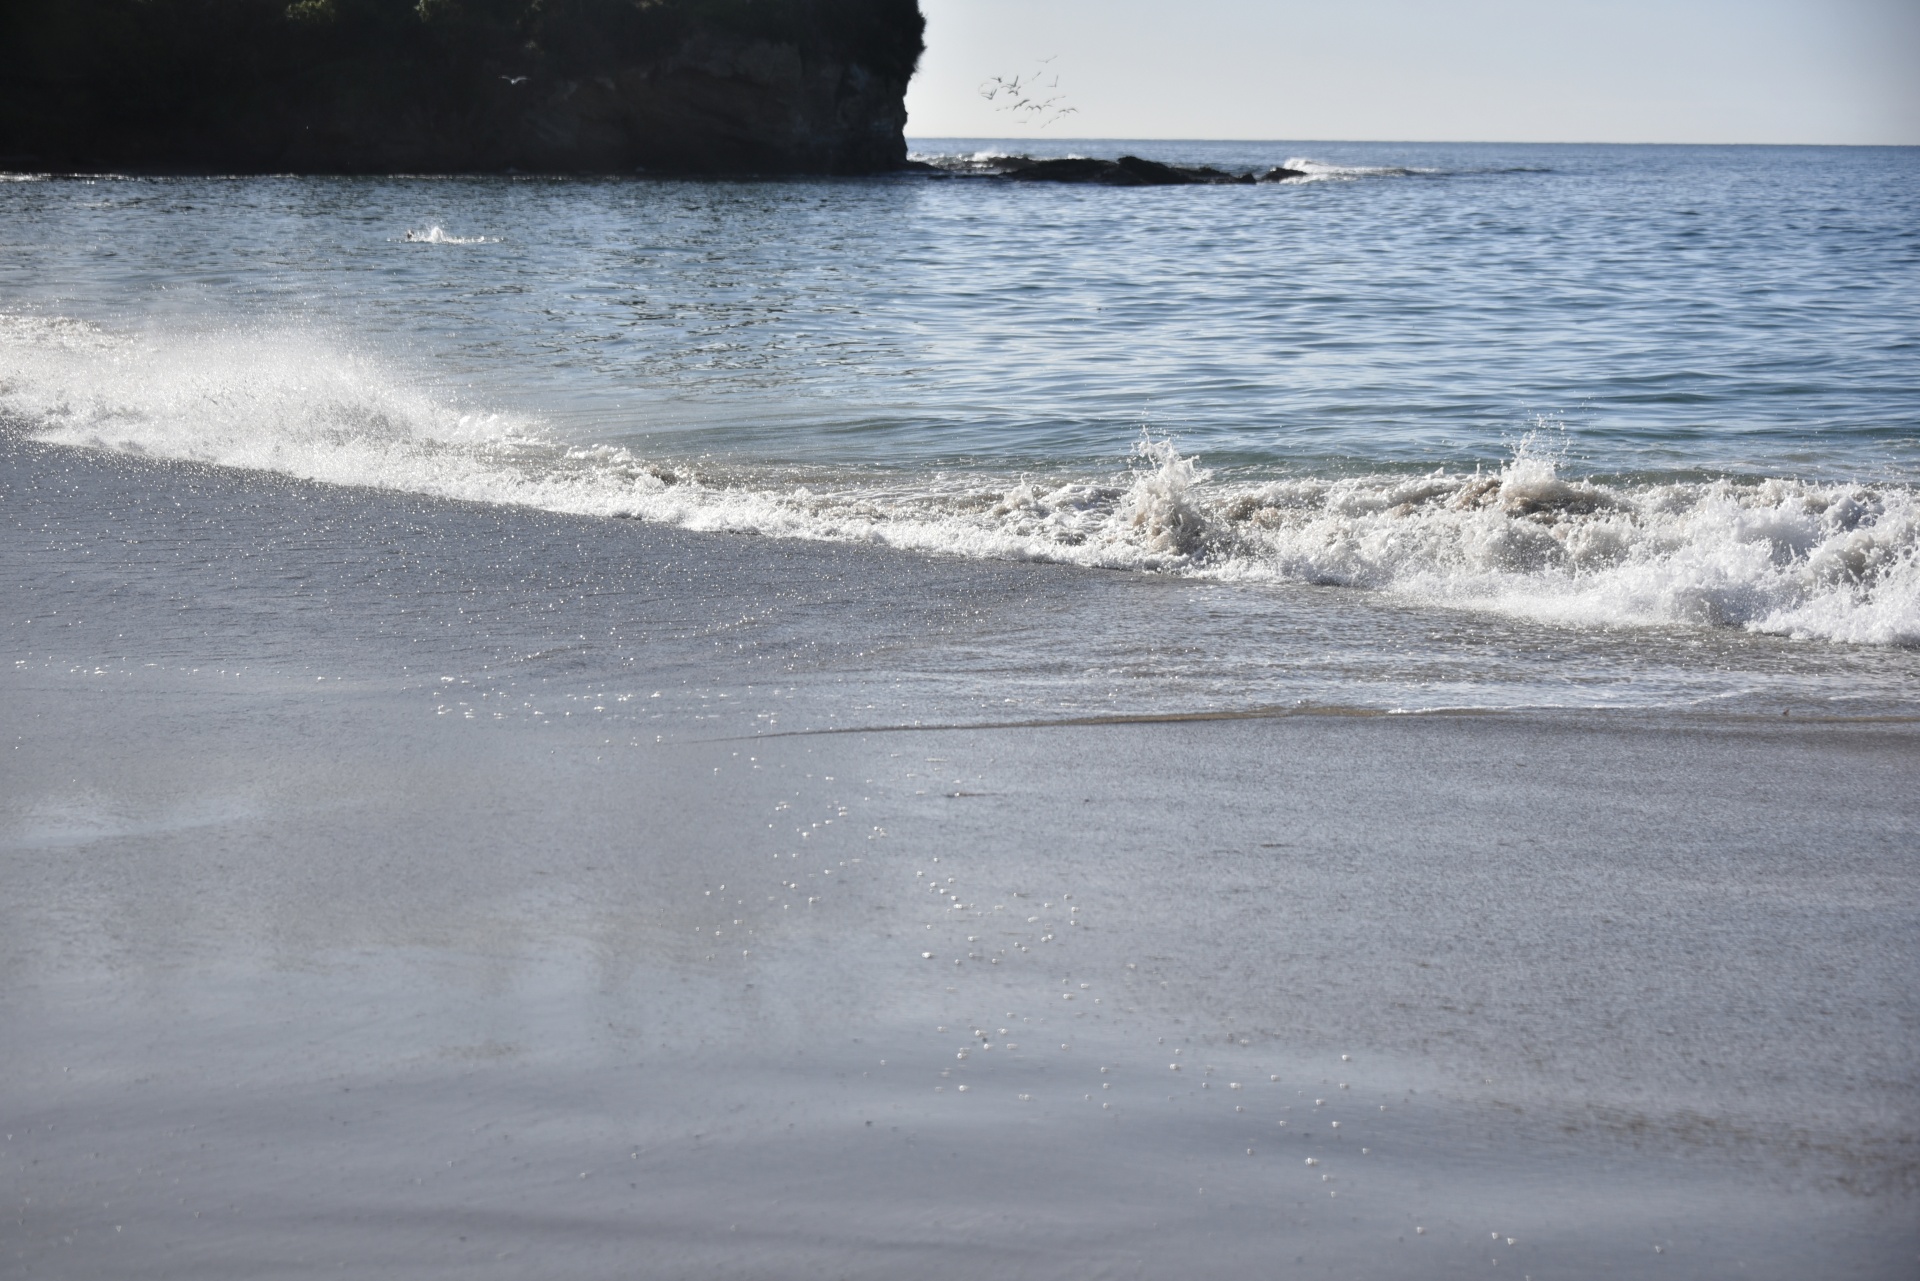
0,317,1920,645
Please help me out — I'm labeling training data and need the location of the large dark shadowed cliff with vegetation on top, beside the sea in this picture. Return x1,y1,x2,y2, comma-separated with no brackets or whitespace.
0,0,925,173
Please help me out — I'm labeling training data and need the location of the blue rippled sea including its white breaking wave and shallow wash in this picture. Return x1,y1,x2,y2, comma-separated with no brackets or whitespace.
0,140,1920,713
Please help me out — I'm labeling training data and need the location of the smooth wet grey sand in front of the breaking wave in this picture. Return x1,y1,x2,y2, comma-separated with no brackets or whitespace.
11,444,1920,1277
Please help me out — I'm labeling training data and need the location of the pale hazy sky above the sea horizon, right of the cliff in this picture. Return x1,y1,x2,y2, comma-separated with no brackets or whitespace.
906,0,1920,144
